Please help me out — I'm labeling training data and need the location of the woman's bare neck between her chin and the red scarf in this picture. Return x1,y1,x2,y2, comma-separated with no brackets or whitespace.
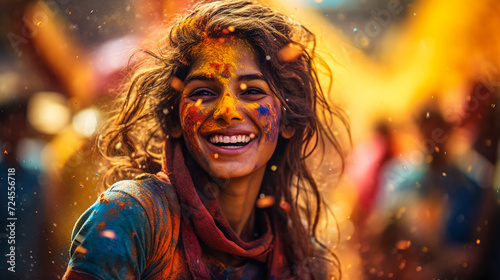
217,165,266,241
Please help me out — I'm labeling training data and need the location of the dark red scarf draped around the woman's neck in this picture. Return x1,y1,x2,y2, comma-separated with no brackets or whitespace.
158,139,288,279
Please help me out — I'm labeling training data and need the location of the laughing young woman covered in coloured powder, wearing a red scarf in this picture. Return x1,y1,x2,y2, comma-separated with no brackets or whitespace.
65,0,346,279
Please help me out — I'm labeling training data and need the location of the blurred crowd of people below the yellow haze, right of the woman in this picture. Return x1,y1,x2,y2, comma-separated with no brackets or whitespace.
349,95,500,279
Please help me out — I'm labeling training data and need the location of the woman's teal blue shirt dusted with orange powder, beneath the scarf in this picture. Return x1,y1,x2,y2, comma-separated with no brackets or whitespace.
69,176,266,280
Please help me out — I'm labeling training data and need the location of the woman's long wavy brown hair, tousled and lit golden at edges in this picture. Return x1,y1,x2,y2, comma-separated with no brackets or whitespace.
98,0,349,278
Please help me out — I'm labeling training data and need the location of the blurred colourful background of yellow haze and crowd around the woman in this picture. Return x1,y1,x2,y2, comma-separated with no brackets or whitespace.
0,0,500,280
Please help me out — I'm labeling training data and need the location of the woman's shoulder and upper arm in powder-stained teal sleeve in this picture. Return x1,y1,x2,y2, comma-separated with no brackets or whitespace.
69,175,179,279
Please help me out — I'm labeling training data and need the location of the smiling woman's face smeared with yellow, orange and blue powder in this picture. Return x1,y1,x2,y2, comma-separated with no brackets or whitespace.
180,39,281,178
